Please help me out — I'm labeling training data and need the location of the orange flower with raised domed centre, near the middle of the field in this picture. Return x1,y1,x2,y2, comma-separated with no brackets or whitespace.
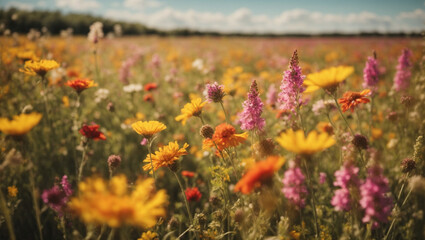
203,123,248,151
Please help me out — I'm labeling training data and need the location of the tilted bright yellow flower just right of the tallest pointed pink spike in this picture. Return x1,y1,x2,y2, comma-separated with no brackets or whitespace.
304,66,354,93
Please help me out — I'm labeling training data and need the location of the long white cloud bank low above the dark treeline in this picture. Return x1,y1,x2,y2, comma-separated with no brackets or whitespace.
106,7,425,33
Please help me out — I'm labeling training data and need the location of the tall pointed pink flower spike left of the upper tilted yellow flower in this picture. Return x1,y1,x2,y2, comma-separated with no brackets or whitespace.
277,50,305,114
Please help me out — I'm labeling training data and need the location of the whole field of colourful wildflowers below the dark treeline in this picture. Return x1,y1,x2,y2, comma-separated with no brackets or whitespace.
0,33,425,240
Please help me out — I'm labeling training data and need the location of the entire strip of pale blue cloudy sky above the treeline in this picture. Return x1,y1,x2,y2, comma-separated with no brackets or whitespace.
0,0,425,33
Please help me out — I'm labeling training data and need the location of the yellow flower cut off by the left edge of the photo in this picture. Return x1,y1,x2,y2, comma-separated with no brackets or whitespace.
0,112,42,136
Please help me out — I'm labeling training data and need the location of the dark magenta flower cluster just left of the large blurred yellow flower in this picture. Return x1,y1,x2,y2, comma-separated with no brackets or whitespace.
41,175,73,216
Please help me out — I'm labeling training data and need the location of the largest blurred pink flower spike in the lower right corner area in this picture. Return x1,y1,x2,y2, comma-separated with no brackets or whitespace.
360,164,393,228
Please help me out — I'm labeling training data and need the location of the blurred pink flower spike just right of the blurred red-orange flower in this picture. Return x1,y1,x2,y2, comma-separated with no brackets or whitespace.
282,163,308,208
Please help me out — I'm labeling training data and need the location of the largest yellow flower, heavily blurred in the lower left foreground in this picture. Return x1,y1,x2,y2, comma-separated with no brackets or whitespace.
68,175,167,228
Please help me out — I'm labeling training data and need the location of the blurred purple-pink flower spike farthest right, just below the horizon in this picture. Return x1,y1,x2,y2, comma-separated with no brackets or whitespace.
394,48,412,92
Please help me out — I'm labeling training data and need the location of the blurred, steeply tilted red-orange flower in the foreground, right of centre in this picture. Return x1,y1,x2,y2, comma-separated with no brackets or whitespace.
234,156,285,194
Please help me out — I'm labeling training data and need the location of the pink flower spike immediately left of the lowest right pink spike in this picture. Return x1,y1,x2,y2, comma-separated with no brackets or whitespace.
331,162,360,211
